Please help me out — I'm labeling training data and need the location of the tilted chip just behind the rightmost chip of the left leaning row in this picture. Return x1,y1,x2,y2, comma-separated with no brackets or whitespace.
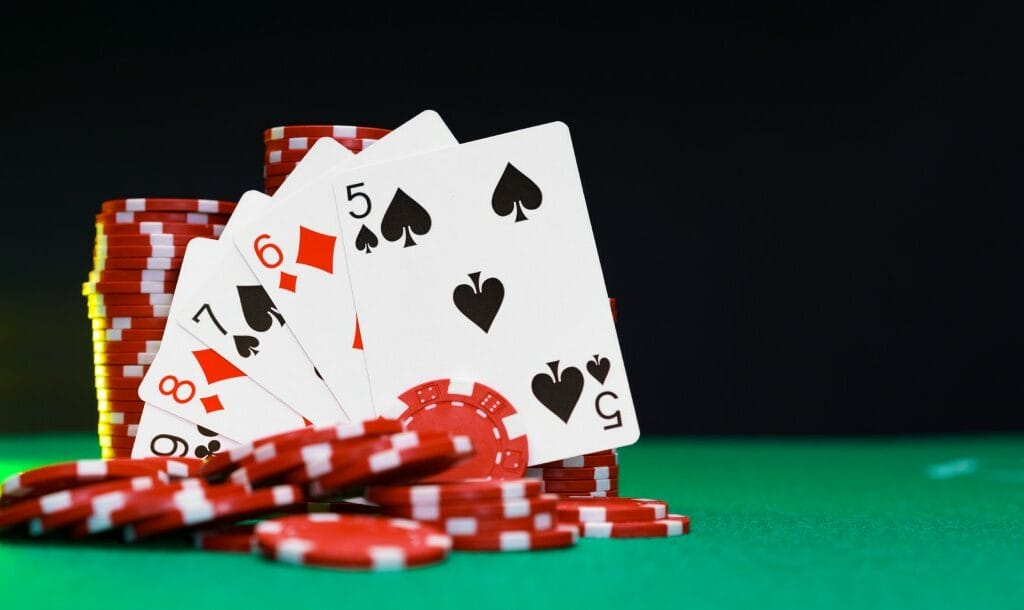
72,479,239,537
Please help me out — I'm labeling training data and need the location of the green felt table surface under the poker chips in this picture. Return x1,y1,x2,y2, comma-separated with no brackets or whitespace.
0,434,1024,610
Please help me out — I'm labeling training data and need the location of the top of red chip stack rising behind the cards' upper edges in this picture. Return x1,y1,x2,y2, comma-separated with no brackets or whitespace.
263,125,390,194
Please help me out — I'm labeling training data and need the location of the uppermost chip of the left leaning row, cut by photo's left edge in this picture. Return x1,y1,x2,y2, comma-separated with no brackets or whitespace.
0,460,172,502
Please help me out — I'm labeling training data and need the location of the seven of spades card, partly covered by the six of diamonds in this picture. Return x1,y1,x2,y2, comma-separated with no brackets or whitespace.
174,190,352,426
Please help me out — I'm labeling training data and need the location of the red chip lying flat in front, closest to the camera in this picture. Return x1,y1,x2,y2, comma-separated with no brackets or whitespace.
256,513,452,570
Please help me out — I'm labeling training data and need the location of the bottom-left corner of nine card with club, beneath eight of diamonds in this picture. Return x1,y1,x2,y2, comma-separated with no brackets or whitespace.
131,404,239,460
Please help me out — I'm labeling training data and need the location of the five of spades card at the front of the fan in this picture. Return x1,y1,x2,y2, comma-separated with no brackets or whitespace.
334,123,639,464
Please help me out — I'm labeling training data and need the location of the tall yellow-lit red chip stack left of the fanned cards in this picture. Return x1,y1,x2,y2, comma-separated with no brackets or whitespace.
82,199,234,458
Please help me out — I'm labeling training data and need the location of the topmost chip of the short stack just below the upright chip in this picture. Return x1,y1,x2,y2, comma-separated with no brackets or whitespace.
367,479,541,506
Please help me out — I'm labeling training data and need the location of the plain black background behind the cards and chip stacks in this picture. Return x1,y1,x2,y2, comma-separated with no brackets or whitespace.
0,3,1024,434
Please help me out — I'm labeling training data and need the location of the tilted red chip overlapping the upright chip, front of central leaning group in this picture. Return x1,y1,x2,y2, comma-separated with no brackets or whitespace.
309,433,473,497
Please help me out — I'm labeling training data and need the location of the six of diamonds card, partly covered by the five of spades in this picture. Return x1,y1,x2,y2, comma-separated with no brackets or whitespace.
234,111,456,421
